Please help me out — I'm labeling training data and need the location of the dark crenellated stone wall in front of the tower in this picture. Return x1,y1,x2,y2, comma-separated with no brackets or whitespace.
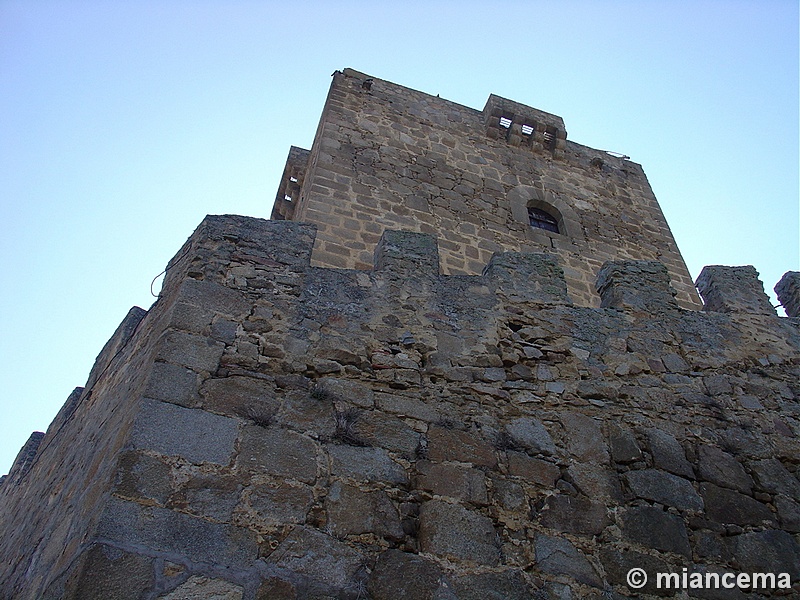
0,215,800,600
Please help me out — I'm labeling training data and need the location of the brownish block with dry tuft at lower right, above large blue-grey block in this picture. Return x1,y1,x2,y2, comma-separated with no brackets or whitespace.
200,377,280,425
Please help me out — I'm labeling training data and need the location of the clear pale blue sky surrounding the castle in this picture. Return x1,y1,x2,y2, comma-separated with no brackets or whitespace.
0,0,800,473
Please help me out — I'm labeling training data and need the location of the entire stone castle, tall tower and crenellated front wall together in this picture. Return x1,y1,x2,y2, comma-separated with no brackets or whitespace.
0,70,800,600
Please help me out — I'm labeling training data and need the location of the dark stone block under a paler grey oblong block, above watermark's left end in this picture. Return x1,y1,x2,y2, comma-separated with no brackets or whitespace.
622,506,692,558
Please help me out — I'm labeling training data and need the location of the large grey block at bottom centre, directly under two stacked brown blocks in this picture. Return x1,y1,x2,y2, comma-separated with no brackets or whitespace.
419,500,500,566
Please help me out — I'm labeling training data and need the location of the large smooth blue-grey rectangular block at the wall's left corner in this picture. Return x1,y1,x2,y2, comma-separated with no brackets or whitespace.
131,400,239,465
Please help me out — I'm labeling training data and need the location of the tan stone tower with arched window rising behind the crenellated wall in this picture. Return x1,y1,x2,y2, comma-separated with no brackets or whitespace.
273,69,701,308
